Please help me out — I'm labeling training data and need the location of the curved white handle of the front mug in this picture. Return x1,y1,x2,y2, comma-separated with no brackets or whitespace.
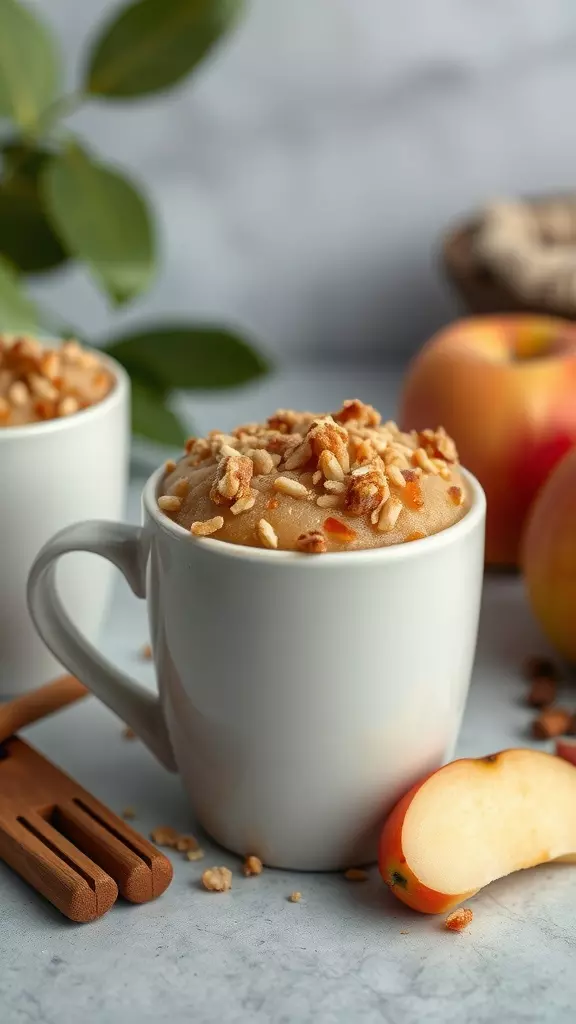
28,520,176,771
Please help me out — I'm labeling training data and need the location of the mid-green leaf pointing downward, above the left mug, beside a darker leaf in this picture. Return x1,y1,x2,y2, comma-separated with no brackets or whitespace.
41,143,155,304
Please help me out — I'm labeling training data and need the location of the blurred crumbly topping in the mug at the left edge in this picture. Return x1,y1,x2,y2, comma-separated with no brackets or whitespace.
0,334,114,427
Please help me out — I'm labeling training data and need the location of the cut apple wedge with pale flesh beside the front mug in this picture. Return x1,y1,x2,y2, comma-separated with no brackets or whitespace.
378,750,576,913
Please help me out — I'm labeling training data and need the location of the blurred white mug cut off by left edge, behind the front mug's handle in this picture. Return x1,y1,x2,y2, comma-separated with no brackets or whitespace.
0,343,130,700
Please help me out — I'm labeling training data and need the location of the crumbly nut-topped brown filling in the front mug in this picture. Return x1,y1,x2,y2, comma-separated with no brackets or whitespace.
158,398,469,554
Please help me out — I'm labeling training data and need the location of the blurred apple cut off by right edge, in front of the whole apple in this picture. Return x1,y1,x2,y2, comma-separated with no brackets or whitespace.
522,447,576,662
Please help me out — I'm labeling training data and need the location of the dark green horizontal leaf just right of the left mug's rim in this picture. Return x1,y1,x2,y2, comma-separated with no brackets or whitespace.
106,326,268,389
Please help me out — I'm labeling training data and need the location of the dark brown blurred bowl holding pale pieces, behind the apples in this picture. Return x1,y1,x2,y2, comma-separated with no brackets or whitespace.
442,198,576,319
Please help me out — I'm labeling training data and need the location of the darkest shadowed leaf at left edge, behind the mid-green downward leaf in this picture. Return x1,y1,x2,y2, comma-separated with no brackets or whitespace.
0,144,68,273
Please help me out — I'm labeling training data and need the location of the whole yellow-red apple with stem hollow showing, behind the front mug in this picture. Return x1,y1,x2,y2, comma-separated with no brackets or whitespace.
400,314,576,566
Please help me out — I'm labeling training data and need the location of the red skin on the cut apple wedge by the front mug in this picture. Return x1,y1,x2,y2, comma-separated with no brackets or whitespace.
378,769,477,913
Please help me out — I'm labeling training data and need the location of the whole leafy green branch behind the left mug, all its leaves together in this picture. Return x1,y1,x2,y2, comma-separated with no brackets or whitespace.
0,0,266,444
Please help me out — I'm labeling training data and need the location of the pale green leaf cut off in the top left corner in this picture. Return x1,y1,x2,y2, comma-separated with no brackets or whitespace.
0,0,58,132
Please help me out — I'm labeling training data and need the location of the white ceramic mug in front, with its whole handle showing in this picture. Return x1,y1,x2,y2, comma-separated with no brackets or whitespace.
29,471,485,870
